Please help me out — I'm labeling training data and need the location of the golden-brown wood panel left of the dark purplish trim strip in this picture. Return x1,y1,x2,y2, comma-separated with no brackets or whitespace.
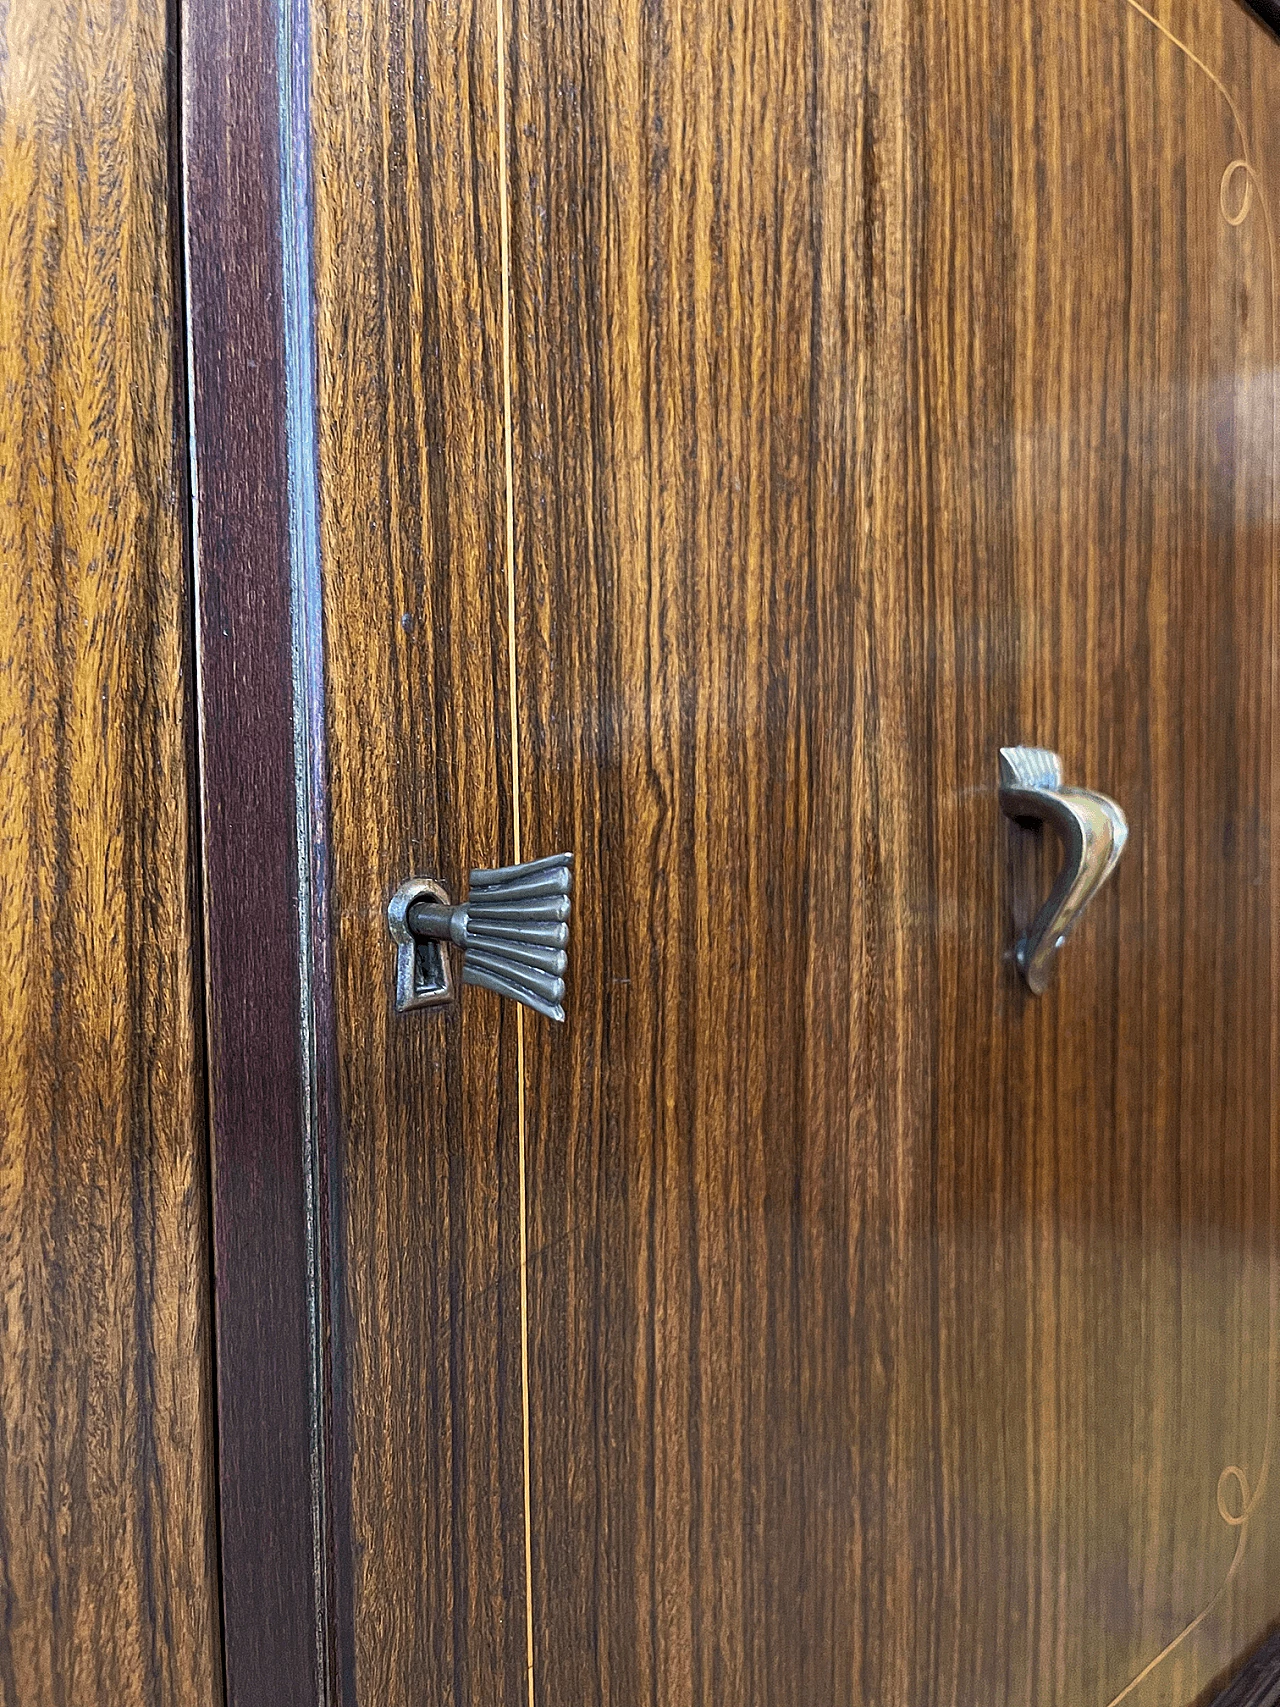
0,0,220,1707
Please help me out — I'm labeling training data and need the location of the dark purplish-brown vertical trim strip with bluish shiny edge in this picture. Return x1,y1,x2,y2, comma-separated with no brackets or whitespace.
183,0,341,1707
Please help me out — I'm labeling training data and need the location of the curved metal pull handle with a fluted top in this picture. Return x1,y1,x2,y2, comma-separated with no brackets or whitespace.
1000,748,1128,995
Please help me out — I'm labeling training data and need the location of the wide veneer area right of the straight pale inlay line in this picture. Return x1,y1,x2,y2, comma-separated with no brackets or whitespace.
507,0,1280,1704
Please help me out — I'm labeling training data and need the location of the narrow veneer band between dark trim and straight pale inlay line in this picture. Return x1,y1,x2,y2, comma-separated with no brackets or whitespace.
312,0,526,1707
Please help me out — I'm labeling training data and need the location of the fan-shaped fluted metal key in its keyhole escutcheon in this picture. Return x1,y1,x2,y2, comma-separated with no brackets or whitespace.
387,854,573,1021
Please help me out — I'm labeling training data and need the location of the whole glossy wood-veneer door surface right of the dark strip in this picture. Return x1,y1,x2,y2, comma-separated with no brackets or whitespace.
303,0,1280,1707
